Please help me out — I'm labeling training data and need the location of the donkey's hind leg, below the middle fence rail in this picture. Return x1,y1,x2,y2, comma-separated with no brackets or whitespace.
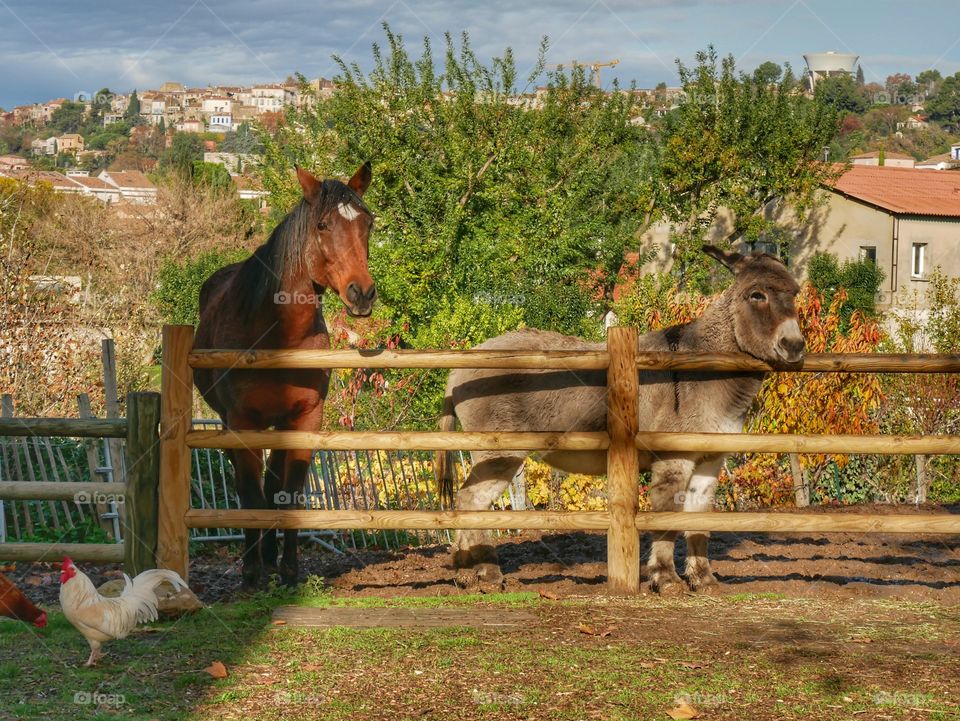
453,451,527,586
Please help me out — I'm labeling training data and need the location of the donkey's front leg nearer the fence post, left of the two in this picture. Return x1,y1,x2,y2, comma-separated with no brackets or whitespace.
647,456,694,595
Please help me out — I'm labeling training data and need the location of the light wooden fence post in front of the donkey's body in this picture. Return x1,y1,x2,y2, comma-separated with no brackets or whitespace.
607,326,640,594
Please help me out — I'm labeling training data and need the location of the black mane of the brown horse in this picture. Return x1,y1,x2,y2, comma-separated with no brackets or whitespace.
235,180,370,317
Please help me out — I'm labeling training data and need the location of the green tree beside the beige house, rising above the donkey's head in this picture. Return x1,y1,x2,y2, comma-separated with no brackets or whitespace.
656,48,839,291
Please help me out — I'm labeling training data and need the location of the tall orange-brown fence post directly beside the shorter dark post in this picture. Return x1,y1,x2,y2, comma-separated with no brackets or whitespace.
157,325,193,580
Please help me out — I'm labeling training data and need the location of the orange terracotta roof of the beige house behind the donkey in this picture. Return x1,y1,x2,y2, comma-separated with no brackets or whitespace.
833,165,960,218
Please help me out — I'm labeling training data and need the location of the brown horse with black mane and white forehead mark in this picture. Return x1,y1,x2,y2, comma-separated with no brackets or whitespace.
194,163,377,588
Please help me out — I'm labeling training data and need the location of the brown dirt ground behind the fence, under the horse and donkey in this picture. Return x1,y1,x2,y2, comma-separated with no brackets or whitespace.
7,505,960,605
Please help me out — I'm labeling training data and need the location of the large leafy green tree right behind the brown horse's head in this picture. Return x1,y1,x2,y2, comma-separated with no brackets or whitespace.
260,27,650,347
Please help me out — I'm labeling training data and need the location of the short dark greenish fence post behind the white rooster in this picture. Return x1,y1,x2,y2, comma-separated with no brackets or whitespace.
123,393,160,576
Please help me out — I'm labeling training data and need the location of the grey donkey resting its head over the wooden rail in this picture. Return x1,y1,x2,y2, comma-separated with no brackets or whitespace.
436,246,805,594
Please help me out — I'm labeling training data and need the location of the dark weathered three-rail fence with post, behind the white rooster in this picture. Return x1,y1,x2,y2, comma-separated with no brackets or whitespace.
0,393,160,575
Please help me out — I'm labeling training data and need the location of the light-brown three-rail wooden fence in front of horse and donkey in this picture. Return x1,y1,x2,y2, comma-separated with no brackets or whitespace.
157,326,960,593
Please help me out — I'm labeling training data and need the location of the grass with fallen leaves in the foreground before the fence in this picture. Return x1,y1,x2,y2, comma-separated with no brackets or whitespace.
0,582,960,721
